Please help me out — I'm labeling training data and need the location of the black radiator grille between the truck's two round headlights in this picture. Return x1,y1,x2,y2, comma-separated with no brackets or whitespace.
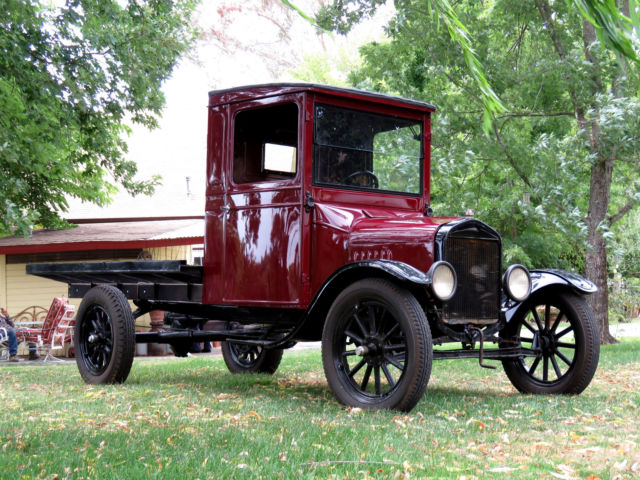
443,235,501,324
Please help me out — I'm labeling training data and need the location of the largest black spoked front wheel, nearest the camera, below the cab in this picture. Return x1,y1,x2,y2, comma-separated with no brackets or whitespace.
322,278,433,412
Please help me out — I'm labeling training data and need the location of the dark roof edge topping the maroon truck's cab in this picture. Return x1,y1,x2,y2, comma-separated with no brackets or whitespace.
209,83,436,112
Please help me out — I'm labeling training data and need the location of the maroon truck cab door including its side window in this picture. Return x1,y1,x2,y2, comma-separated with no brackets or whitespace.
222,96,304,307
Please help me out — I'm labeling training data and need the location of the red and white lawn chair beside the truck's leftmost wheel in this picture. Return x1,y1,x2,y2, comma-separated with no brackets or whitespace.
16,297,76,362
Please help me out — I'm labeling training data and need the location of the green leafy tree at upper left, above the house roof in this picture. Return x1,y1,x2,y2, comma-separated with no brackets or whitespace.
0,0,196,234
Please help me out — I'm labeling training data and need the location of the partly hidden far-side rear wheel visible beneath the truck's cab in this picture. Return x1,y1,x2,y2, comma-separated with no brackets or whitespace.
220,342,284,374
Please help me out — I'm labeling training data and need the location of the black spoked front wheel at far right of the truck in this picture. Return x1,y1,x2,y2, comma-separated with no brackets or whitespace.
500,290,600,394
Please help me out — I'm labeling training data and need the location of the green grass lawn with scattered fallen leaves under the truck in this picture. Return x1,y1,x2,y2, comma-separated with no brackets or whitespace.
0,338,640,480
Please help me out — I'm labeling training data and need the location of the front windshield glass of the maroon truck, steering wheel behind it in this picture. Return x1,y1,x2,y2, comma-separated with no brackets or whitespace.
313,105,424,195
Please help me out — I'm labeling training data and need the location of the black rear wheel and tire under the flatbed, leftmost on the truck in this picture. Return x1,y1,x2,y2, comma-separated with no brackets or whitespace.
74,285,136,384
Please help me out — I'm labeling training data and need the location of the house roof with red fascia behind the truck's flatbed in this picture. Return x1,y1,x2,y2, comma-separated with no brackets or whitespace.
0,217,204,254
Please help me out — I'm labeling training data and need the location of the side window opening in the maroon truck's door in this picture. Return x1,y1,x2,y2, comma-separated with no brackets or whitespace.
233,103,298,184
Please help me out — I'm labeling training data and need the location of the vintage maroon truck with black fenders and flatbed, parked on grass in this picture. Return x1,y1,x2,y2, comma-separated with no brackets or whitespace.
27,84,599,411
